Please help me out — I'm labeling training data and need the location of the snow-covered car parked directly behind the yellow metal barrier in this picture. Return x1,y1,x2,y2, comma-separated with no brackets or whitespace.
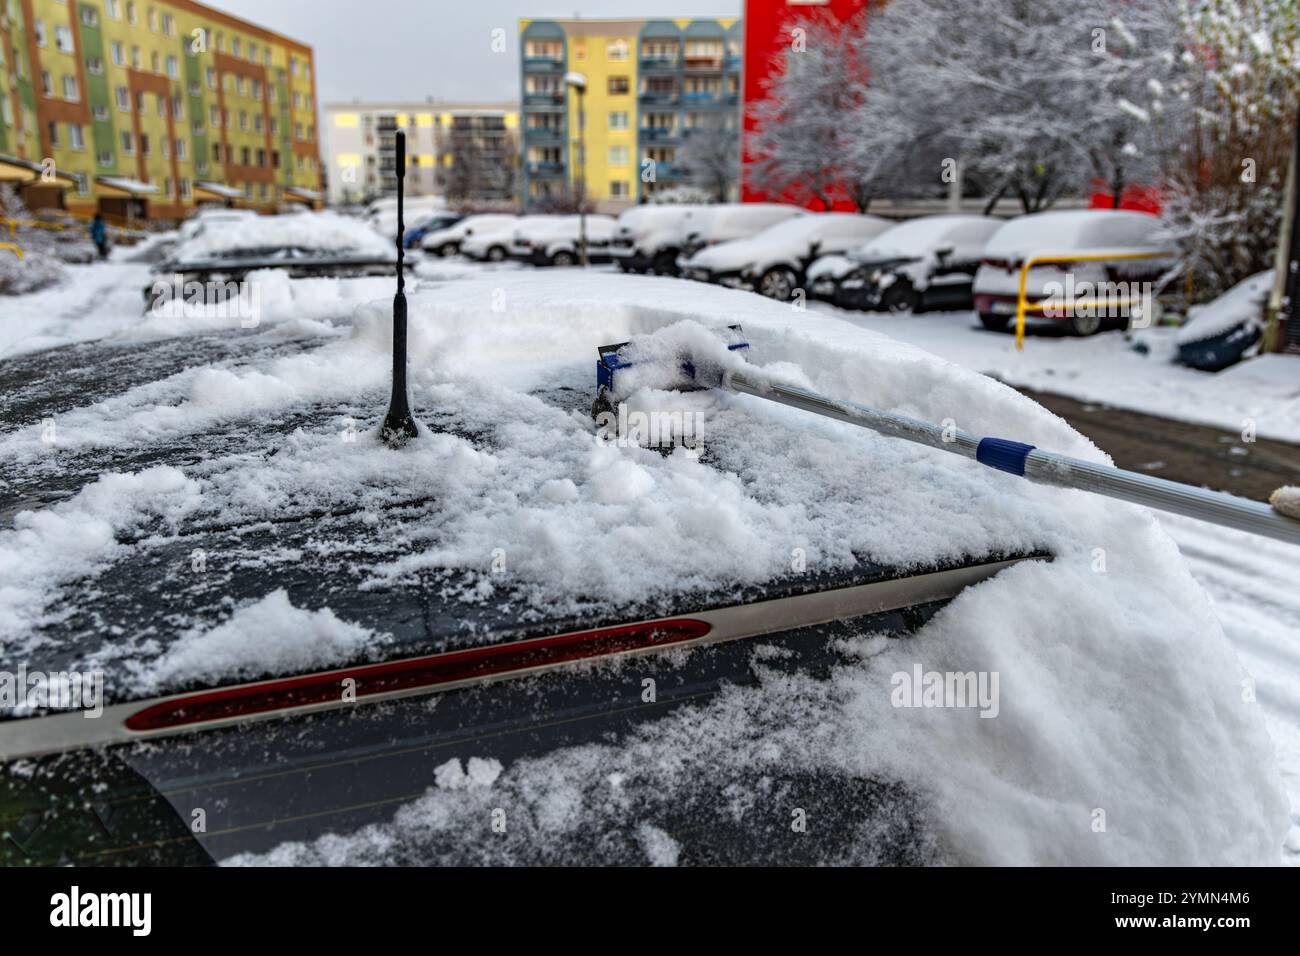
972,209,1171,336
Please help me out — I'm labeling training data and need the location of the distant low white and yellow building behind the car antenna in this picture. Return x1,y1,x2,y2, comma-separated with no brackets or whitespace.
324,101,519,206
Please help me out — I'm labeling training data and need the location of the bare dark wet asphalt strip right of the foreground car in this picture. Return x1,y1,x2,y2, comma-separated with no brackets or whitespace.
1021,389,1300,501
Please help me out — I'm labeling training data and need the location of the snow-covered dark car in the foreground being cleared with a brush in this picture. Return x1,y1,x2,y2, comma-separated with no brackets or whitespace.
0,271,1288,865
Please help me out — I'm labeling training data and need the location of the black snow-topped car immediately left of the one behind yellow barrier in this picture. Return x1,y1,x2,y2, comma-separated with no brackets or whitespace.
807,215,1002,312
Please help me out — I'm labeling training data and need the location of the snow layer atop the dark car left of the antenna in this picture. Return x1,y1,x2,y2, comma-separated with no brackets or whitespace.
173,212,397,263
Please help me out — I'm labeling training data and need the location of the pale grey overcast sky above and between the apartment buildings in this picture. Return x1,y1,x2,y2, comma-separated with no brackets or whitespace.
211,0,744,103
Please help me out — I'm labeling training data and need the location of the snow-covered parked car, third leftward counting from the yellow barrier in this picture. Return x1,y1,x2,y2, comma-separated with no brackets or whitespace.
681,212,893,302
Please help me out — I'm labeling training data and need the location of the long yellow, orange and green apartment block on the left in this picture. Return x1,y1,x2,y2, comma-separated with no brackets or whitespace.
0,0,321,220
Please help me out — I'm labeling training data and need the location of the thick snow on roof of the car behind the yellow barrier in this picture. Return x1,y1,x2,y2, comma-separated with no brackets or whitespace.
984,209,1167,261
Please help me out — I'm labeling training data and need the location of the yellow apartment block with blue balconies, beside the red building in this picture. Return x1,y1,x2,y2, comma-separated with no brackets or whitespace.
519,20,744,212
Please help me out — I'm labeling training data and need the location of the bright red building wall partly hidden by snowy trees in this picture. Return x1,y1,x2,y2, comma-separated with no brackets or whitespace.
741,0,883,212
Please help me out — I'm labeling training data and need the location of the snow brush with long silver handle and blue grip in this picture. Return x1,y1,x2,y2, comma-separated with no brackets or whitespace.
593,325,1300,545
